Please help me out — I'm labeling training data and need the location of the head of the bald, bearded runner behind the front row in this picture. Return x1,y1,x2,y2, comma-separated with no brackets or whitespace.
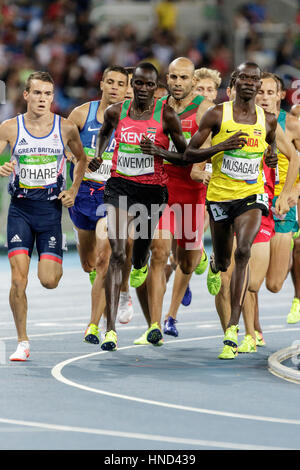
167,63,196,100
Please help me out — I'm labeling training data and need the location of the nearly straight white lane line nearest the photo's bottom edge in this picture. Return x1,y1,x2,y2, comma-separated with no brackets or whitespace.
0,418,292,450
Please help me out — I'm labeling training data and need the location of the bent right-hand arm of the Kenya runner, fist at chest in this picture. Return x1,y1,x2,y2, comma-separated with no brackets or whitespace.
140,105,187,166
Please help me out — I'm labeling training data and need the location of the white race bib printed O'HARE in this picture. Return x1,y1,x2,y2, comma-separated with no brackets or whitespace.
19,155,57,189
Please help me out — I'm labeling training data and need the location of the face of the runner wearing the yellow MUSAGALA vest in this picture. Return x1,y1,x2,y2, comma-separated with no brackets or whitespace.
235,65,261,101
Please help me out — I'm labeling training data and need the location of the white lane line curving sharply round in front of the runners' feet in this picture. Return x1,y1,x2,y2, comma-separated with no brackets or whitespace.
51,328,300,426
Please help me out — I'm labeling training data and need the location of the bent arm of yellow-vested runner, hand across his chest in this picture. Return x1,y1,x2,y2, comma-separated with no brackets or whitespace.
183,104,248,163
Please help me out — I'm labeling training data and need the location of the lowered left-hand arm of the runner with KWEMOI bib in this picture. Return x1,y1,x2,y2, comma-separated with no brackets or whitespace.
88,103,122,171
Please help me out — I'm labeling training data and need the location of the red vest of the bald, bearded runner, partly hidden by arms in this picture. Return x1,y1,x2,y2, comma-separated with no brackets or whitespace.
161,95,206,191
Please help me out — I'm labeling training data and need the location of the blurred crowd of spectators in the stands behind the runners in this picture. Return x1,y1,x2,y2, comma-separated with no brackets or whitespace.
0,0,300,121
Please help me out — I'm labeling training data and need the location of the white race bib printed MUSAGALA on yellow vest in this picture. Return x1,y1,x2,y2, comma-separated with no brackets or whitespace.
221,151,262,181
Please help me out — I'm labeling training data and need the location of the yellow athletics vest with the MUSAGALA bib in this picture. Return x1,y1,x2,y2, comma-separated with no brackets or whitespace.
207,101,268,201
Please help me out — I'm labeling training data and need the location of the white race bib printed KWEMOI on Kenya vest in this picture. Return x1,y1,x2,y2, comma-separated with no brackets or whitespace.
116,143,154,176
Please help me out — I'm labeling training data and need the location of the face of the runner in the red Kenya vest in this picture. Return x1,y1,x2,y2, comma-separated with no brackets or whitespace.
131,68,157,104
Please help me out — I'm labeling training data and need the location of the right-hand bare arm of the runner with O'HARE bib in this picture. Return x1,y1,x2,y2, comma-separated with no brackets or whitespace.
58,119,87,207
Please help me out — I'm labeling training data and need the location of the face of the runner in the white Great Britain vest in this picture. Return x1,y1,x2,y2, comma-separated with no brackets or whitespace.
23,79,54,115
